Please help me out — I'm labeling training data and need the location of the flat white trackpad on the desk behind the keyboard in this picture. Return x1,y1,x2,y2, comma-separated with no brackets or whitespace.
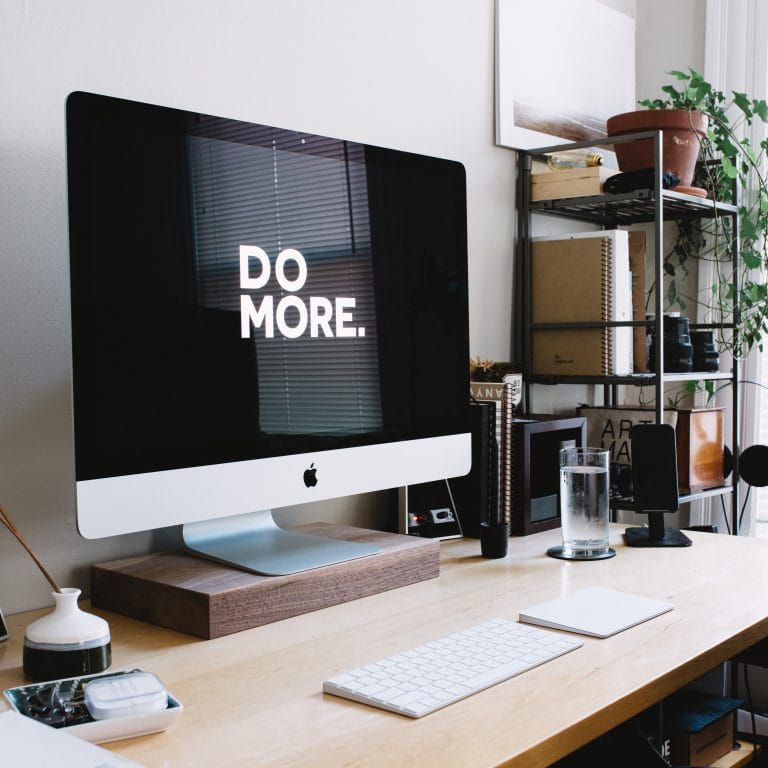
520,587,673,637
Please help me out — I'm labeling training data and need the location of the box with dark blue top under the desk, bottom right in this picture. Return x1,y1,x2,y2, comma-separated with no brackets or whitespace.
665,690,741,766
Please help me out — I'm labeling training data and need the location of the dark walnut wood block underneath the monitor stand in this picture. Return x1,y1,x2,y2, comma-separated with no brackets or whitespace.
91,523,440,639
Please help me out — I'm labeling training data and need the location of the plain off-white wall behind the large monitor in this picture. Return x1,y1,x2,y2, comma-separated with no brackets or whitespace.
0,0,704,613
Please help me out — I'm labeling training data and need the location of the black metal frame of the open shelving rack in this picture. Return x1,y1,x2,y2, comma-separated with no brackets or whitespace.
515,131,741,533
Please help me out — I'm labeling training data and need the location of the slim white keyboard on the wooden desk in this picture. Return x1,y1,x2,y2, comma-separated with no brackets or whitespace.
323,619,583,717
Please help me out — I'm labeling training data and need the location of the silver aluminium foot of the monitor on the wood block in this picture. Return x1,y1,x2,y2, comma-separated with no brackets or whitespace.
182,509,381,576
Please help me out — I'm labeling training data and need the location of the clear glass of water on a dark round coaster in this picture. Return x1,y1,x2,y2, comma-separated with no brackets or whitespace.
548,448,616,560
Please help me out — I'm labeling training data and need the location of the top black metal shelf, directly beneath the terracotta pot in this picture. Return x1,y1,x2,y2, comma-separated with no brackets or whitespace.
528,189,738,225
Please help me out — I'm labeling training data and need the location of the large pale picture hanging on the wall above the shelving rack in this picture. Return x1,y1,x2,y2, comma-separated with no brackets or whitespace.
495,0,636,149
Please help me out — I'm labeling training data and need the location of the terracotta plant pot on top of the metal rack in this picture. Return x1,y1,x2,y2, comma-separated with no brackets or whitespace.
608,109,707,187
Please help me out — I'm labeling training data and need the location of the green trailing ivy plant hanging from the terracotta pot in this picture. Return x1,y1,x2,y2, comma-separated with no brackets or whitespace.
640,68,768,358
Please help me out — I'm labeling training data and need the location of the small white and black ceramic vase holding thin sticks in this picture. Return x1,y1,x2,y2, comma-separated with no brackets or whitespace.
24,588,112,680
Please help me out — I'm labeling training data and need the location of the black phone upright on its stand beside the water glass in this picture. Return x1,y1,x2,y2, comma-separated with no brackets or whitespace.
624,424,691,547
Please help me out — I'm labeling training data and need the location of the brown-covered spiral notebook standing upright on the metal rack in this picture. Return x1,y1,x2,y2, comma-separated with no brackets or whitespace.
531,230,633,376
